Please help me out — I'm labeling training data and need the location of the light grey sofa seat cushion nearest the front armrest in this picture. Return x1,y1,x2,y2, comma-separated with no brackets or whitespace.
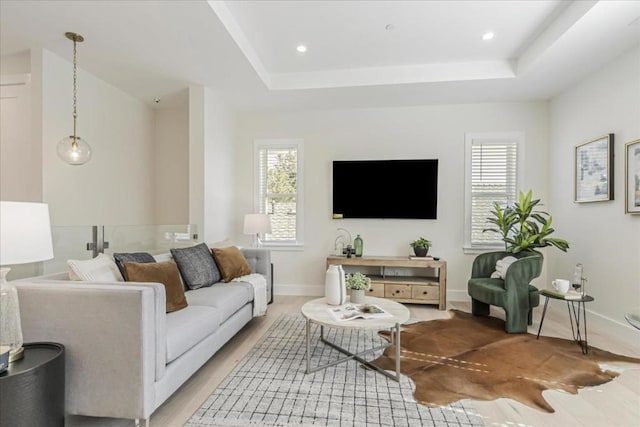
167,305,222,364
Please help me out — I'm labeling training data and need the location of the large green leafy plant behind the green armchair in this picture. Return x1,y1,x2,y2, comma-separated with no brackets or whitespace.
482,190,569,253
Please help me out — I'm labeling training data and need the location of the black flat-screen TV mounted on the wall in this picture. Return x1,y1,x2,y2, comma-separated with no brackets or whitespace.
333,159,438,219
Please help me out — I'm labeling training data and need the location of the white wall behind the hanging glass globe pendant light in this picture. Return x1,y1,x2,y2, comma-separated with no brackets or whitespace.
42,50,155,226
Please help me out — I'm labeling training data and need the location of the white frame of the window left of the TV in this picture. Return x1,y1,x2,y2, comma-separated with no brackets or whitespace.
253,138,304,250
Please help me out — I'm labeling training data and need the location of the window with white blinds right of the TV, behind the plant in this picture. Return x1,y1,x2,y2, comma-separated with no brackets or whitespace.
465,133,524,248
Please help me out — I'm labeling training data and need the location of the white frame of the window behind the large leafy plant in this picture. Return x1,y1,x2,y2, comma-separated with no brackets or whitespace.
463,132,525,253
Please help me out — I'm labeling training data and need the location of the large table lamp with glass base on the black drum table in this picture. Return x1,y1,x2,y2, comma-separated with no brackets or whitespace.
0,201,53,362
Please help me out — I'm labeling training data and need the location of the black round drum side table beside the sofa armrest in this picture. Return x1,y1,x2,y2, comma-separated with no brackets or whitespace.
0,342,65,427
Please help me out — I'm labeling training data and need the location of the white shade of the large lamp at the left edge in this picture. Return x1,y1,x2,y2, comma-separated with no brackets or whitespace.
0,202,53,265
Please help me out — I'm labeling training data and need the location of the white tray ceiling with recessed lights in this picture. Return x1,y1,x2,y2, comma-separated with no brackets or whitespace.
0,0,640,110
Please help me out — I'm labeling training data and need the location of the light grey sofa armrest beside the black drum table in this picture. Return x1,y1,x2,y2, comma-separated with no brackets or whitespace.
14,280,166,418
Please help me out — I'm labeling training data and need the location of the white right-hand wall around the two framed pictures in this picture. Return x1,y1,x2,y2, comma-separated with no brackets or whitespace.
548,48,640,334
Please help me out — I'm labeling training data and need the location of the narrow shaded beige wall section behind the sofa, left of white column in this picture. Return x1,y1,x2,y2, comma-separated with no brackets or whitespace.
153,108,189,224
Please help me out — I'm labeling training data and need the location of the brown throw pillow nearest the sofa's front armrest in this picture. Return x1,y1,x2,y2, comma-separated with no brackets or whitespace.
123,261,188,313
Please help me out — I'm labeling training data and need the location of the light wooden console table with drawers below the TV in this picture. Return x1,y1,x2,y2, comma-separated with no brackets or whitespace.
327,256,447,310
